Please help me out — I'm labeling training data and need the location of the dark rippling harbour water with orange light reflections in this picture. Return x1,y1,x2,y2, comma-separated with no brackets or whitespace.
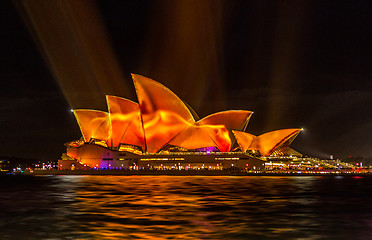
0,176,372,239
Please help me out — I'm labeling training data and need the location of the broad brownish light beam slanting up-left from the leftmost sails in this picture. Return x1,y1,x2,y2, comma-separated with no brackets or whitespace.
15,0,131,110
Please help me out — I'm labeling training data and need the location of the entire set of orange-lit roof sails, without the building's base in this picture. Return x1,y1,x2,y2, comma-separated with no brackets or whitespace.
70,74,302,156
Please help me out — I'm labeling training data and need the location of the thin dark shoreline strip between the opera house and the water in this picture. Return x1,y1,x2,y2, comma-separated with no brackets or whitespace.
22,169,372,176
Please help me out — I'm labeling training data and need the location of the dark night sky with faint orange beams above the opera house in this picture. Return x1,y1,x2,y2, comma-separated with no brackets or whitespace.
0,0,372,160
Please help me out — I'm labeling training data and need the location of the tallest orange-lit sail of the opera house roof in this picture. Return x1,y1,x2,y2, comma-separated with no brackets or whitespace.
132,74,195,153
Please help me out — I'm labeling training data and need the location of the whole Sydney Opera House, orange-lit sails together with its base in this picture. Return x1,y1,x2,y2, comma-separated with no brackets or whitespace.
59,74,301,170
